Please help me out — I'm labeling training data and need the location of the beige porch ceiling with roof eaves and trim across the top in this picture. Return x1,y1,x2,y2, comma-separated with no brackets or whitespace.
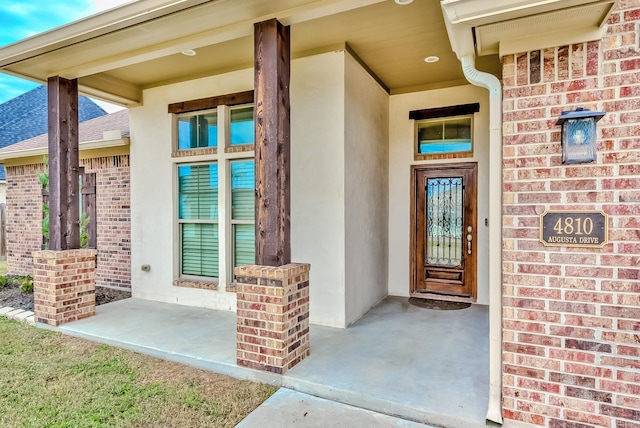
0,0,615,105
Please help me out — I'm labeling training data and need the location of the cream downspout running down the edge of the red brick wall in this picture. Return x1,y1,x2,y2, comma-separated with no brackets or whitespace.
460,54,502,424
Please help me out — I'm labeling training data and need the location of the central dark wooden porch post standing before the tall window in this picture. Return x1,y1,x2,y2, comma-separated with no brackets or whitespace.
254,19,291,266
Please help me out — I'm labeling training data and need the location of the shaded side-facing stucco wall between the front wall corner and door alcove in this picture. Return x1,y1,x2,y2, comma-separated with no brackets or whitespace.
344,55,389,324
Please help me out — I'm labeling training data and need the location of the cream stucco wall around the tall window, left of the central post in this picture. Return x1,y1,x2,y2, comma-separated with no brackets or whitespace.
130,70,253,310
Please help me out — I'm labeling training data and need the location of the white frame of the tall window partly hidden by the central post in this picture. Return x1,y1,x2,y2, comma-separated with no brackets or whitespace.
172,104,255,291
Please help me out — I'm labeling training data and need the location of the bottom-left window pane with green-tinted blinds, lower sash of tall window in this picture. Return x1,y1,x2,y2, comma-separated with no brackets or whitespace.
180,223,218,278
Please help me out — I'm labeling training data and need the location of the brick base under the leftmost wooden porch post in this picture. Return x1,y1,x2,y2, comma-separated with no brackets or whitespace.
33,249,98,326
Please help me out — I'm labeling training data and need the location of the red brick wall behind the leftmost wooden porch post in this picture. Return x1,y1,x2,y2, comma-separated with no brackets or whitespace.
6,155,131,288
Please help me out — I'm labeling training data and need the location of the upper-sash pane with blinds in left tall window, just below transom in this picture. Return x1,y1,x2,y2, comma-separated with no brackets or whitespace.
178,163,218,220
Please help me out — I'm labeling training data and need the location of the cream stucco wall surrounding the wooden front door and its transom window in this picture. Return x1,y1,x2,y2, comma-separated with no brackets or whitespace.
389,85,489,304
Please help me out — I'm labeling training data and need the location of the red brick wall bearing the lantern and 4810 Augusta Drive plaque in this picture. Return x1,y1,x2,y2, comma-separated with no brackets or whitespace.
503,0,640,428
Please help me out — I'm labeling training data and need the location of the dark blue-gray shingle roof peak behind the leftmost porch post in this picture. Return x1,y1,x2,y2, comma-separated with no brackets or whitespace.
0,86,107,180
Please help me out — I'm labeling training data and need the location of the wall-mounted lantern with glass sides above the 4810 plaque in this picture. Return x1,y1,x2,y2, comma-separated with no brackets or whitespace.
556,107,606,163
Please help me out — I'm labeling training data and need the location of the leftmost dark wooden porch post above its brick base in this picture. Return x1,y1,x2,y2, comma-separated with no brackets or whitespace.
47,76,80,251
